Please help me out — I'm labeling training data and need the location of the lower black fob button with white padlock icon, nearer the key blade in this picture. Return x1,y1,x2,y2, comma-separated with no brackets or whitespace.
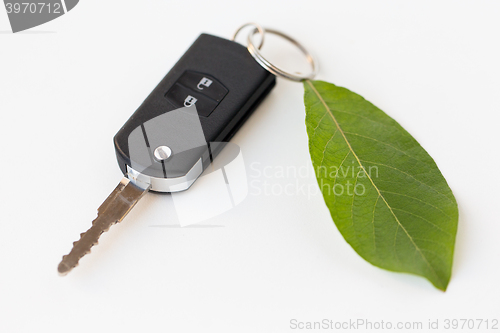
165,83,218,117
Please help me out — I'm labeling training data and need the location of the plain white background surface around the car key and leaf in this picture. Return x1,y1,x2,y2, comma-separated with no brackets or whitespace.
0,0,500,332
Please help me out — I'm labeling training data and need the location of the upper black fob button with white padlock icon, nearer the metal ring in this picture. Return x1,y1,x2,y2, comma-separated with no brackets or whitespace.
177,71,228,102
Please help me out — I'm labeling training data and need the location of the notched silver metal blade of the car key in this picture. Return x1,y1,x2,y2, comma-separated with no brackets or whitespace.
57,177,150,275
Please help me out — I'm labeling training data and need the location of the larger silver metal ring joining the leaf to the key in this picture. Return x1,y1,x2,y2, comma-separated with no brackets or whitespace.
247,28,318,82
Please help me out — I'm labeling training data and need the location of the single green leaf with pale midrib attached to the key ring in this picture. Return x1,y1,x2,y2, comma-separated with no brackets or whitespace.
304,81,458,291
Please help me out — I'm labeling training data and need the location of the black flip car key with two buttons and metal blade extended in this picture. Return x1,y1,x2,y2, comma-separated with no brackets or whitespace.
58,34,276,275
